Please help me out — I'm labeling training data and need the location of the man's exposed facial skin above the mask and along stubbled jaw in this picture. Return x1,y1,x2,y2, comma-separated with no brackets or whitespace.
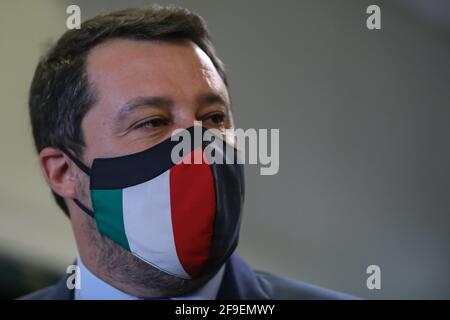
71,40,233,296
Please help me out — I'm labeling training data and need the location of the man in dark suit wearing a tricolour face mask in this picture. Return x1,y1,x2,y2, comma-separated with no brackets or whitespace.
25,6,356,300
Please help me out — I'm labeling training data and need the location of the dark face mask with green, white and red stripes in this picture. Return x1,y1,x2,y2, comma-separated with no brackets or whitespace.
61,127,244,279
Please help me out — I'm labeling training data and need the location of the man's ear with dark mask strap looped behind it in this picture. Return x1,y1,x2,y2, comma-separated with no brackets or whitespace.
39,147,77,199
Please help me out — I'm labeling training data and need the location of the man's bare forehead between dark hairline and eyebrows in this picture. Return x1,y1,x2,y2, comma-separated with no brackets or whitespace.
87,39,228,103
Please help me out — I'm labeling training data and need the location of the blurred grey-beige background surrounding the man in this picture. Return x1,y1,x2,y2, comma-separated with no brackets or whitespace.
0,0,450,299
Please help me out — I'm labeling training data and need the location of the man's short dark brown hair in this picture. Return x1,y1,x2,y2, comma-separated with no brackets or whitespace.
29,6,228,215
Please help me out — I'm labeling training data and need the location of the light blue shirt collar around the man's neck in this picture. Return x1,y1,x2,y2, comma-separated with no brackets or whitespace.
75,258,225,300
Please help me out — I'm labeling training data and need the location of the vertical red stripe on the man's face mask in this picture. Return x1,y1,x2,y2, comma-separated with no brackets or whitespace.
170,149,216,278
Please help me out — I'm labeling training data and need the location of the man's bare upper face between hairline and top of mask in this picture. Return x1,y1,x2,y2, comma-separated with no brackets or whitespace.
82,40,232,163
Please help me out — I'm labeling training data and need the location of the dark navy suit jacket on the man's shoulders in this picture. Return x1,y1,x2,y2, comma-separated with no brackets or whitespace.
21,254,355,300
